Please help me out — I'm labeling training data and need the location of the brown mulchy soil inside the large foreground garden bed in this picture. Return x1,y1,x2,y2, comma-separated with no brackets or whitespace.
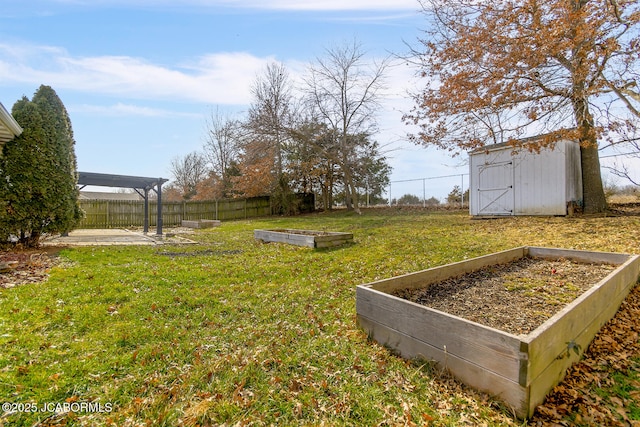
393,257,617,335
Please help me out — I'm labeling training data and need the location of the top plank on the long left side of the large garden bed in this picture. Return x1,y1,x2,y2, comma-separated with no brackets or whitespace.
356,285,522,382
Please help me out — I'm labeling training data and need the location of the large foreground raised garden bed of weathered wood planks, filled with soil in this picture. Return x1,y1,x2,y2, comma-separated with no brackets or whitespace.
356,247,640,418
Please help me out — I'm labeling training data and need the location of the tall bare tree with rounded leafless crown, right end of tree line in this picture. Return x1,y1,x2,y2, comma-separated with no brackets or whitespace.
305,41,389,213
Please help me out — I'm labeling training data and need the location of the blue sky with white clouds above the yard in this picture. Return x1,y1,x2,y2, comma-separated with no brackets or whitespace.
0,0,636,200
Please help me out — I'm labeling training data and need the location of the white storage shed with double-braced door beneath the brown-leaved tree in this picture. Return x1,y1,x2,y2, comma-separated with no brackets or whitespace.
469,140,582,216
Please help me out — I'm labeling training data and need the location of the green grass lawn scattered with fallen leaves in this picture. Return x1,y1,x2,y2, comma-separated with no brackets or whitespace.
0,209,640,426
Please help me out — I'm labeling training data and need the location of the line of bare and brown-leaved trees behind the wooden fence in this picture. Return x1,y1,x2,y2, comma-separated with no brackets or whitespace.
171,41,390,212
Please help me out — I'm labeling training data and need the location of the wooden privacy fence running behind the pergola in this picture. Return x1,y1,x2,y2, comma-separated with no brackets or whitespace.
78,197,272,228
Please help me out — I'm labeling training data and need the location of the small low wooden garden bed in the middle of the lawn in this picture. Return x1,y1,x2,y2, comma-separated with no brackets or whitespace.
253,228,353,248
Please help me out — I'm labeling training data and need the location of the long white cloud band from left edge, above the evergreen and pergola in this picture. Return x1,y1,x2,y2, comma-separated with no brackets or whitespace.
0,44,274,105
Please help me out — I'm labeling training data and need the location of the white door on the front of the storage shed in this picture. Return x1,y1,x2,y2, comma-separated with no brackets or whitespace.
478,161,514,215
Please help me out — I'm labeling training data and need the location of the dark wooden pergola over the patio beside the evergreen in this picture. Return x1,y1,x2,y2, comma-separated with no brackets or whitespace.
78,172,169,236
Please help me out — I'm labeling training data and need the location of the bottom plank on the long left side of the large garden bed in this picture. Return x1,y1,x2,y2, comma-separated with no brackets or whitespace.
358,315,529,417
